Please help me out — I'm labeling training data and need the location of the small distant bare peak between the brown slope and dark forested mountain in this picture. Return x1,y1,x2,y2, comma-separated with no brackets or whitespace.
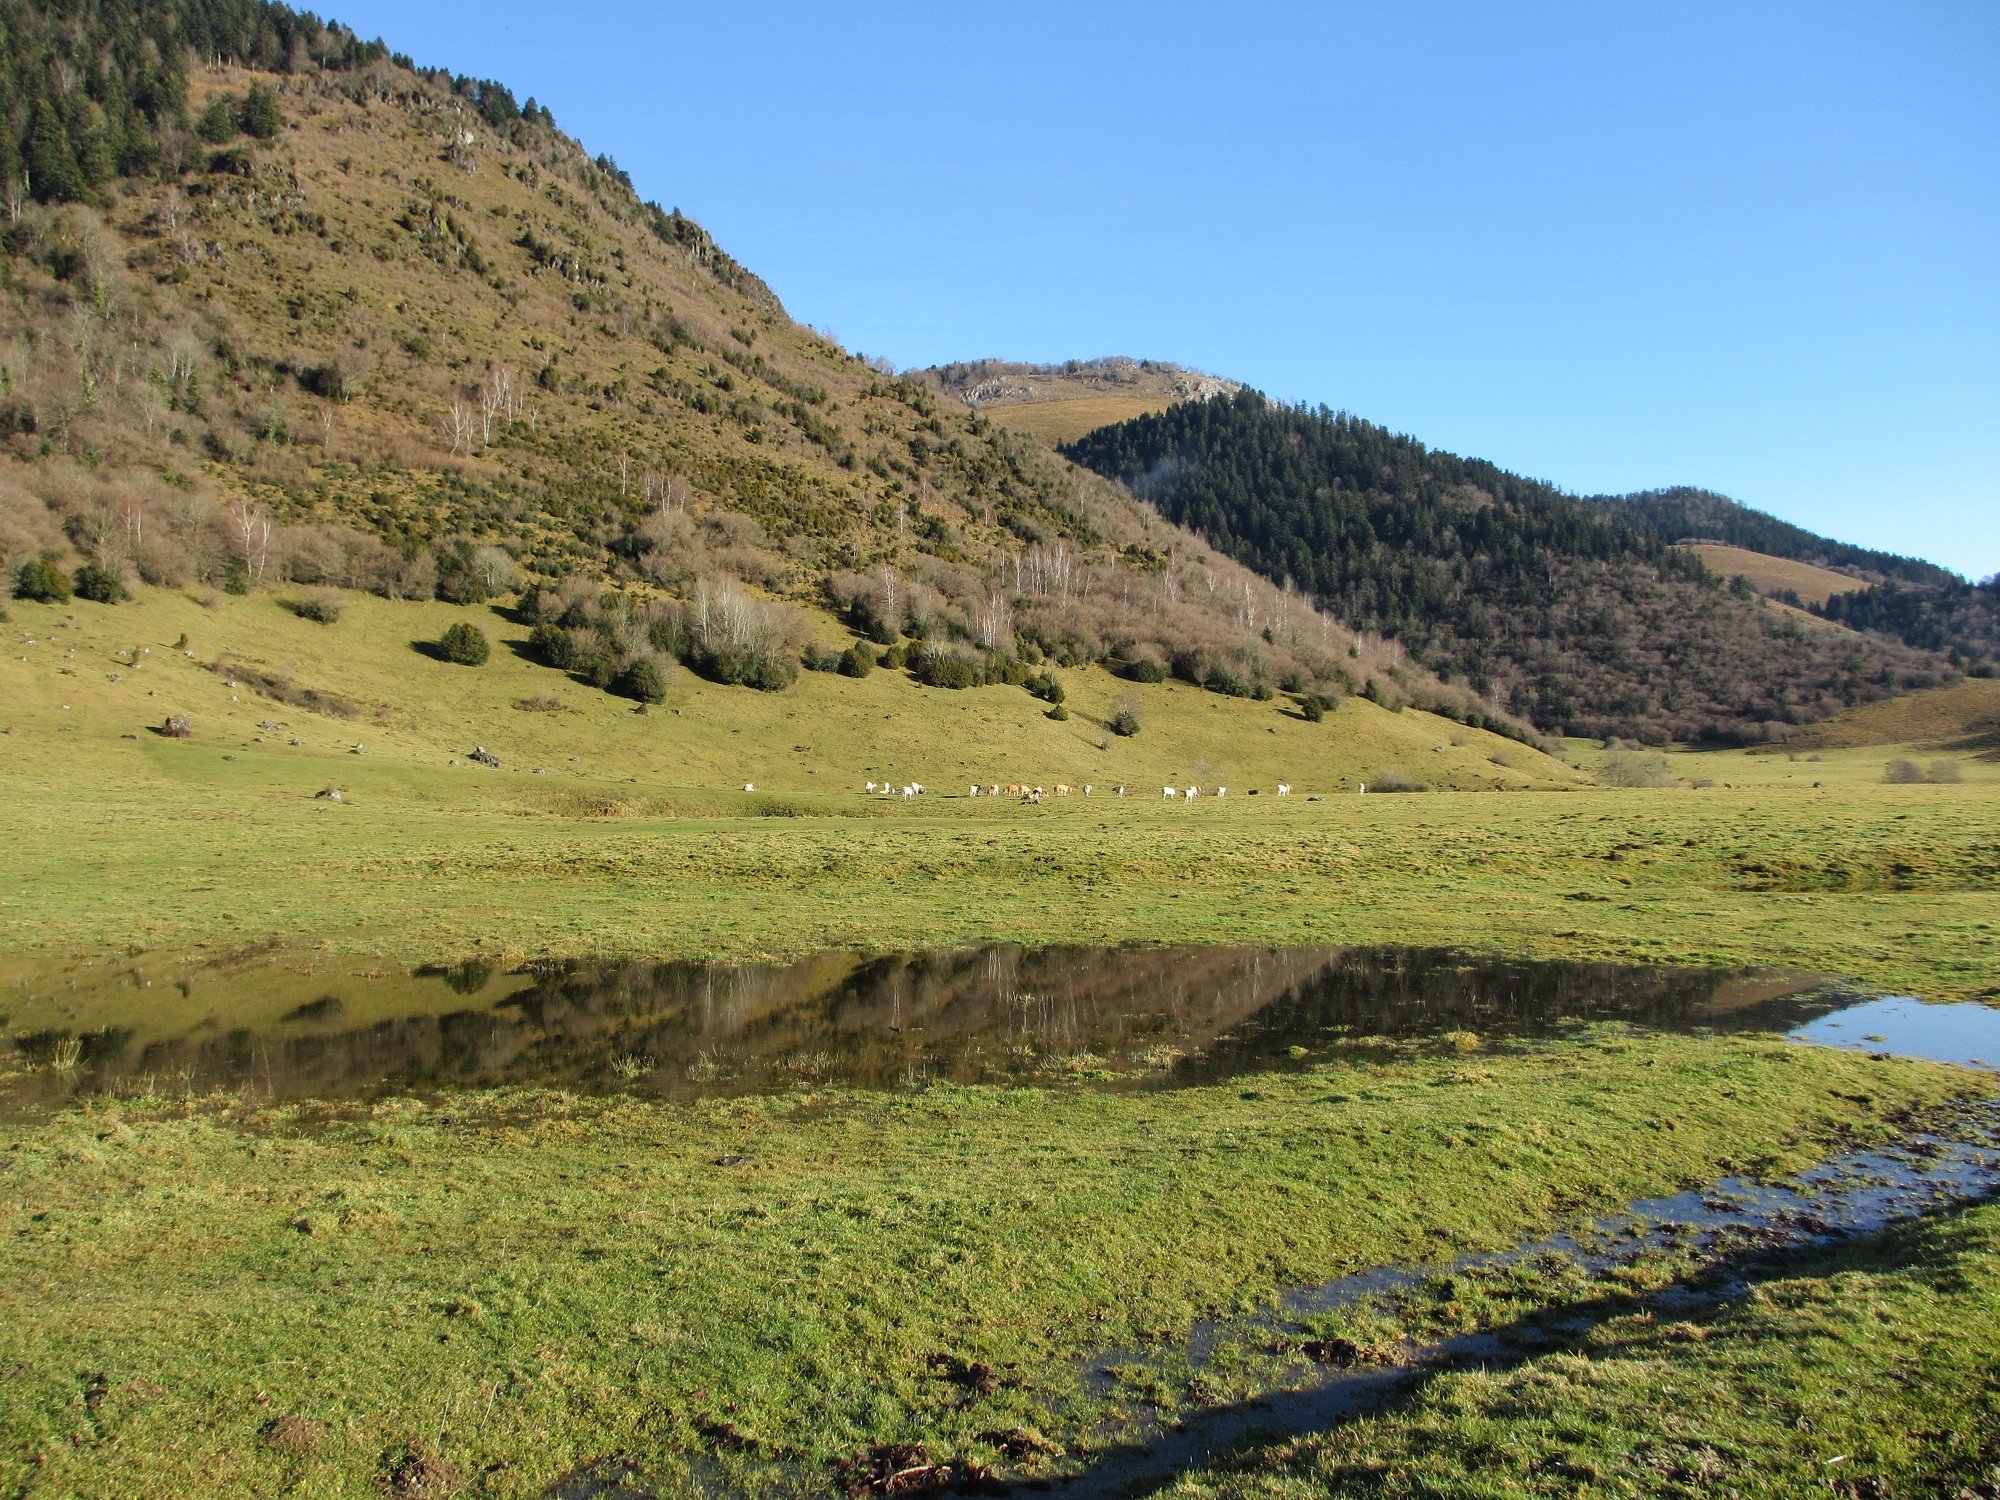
910,356,1242,444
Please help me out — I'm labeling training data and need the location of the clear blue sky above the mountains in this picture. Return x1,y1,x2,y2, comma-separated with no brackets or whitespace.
334,0,2000,576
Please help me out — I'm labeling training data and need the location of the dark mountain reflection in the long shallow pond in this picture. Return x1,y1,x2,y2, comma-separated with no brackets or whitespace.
8,948,1826,1104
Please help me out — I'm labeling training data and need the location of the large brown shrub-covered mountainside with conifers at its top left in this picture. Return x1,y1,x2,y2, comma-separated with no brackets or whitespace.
0,0,1532,738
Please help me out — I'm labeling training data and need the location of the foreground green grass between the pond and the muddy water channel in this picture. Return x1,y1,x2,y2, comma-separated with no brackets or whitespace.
0,1026,1976,1496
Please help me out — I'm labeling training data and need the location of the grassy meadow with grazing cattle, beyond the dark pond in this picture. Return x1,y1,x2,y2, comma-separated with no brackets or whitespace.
0,590,2000,998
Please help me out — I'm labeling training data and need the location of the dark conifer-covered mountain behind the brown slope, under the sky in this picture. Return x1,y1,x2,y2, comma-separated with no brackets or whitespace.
1064,390,1954,742
